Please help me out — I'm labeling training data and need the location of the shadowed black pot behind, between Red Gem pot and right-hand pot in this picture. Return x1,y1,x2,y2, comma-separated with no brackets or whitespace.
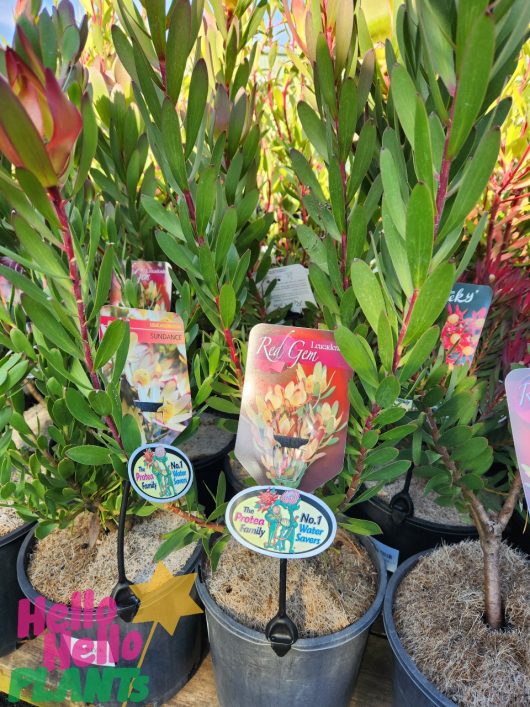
351,490,478,562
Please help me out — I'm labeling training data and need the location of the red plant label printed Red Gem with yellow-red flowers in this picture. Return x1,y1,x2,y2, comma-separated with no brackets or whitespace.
235,324,352,491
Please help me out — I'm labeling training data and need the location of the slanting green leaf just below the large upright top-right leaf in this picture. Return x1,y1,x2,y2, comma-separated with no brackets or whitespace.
440,128,501,238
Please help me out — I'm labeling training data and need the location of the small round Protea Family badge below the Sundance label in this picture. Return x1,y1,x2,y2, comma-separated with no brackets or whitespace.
129,444,193,503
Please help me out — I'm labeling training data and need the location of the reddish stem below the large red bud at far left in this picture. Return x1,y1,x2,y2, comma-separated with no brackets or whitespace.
48,187,123,449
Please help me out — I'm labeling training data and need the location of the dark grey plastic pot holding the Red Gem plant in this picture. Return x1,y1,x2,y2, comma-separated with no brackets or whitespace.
197,538,386,707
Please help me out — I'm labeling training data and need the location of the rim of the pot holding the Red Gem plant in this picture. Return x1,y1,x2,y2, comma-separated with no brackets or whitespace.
195,535,387,652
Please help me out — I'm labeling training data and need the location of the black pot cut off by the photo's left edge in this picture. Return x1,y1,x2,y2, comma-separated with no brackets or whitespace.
0,523,31,655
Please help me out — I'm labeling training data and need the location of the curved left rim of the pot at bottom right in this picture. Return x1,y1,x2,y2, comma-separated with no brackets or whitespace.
383,548,456,707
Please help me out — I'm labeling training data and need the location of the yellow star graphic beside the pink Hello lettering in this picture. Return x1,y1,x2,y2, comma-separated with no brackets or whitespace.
131,562,203,636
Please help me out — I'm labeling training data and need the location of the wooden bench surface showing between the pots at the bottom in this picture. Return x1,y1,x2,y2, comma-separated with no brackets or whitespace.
0,634,392,707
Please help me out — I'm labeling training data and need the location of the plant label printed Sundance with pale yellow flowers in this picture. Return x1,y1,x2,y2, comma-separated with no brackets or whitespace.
100,306,192,439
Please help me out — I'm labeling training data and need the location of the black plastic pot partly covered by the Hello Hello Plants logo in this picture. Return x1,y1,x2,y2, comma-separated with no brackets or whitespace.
17,533,206,707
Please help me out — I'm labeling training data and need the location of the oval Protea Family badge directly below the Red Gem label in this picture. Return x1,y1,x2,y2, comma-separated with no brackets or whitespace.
225,486,337,560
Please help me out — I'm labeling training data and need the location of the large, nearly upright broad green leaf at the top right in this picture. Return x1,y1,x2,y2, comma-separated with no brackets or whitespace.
447,15,495,159
